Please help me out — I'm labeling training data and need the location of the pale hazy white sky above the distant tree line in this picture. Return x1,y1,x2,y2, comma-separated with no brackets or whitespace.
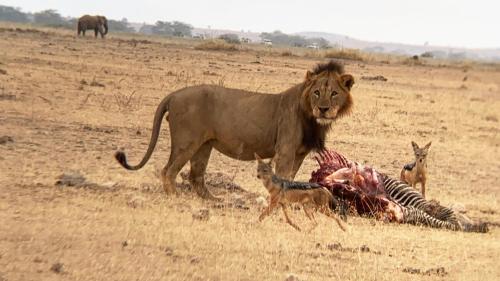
0,0,500,48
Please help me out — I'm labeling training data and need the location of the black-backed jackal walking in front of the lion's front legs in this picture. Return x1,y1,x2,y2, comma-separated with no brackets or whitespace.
255,154,345,231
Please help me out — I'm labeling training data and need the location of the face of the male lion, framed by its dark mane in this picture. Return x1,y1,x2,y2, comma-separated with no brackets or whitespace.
305,71,354,126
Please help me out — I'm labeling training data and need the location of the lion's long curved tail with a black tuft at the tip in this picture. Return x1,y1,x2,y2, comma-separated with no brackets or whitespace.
115,95,170,170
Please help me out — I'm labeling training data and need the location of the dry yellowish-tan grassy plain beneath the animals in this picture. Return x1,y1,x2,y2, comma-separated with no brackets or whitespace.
0,24,500,281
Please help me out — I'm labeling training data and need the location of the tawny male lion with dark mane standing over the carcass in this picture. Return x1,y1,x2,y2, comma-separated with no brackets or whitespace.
115,61,354,198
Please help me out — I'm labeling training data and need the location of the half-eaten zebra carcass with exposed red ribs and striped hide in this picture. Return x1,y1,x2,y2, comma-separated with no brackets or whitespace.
310,150,488,232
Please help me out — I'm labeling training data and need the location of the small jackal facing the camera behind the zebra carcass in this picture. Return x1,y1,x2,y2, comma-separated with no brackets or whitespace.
401,141,432,198
